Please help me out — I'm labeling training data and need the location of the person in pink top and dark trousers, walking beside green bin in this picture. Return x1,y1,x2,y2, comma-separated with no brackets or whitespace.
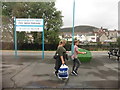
71,40,86,76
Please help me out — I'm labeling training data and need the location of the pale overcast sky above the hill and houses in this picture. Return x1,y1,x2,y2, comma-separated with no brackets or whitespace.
55,0,120,30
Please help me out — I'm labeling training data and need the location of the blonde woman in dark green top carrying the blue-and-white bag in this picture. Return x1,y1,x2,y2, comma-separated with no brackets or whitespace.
55,40,66,76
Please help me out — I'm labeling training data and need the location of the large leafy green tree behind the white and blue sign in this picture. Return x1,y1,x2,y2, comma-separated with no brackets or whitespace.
2,2,63,43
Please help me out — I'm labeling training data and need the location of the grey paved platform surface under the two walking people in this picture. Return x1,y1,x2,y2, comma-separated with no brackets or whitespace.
1,51,120,90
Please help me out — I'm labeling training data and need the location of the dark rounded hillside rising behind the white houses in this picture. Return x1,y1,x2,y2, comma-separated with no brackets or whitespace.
60,25,99,32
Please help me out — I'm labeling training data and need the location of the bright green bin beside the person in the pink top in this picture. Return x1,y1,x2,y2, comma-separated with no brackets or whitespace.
78,49,92,62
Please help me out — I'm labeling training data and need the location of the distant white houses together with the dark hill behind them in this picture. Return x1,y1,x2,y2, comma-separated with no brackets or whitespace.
59,26,120,43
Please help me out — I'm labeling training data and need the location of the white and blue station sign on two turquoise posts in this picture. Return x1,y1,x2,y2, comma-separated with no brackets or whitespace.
14,18,44,59
